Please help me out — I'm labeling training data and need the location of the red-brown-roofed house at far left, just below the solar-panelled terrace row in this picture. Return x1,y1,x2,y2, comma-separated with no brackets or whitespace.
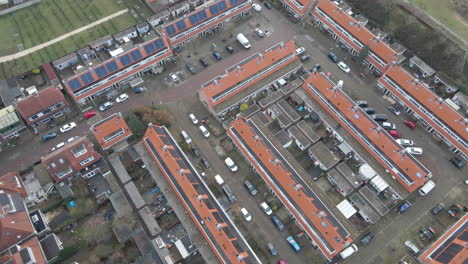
16,86,69,127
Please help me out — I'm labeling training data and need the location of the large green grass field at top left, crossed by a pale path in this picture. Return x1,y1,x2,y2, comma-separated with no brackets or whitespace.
0,0,151,79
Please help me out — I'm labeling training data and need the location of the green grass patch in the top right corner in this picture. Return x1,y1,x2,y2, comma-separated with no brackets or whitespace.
410,0,468,40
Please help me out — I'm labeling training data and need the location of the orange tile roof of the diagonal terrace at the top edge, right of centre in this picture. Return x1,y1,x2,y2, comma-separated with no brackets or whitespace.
312,0,397,71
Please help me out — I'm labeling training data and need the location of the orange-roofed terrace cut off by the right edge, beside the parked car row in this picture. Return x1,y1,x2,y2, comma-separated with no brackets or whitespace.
377,65,468,160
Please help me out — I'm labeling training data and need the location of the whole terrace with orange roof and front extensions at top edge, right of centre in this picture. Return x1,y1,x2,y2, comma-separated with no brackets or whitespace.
311,0,405,74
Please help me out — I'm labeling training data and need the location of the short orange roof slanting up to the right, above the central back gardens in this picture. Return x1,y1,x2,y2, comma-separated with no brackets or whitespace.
199,40,297,108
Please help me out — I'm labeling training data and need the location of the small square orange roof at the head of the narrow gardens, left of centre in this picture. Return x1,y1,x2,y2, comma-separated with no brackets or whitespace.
91,112,132,150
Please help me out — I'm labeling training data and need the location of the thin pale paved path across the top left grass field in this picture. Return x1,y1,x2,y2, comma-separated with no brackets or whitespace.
0,9,128,62
